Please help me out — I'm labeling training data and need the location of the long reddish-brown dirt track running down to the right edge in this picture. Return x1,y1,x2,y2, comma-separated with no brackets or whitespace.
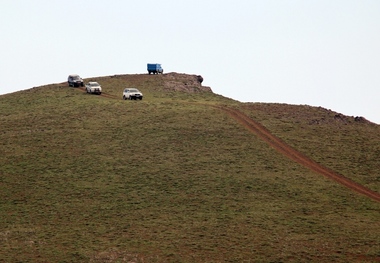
215,106,380,202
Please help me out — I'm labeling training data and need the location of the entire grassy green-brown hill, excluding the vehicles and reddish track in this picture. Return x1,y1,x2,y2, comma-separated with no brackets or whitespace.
0,73,380,262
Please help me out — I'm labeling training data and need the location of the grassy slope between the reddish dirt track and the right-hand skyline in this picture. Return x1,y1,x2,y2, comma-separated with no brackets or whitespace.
242,103,380,193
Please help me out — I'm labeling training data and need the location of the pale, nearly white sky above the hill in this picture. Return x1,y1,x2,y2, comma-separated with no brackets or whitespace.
0,0,380,124
